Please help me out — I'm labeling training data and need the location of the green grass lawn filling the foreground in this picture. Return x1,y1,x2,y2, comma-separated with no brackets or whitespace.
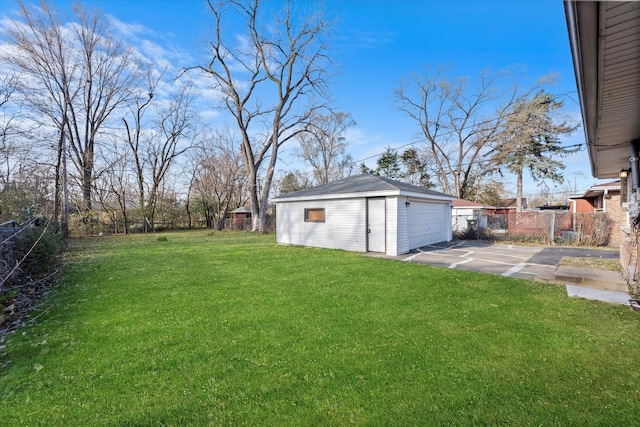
0,231,640,426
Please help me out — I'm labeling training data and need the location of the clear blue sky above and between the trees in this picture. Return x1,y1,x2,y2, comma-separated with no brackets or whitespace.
0,0,596,194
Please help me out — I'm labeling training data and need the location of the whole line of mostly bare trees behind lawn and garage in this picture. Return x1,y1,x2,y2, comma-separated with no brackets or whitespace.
0,0,575,237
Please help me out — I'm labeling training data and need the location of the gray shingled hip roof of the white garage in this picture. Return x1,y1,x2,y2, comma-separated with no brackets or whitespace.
275,174,452,201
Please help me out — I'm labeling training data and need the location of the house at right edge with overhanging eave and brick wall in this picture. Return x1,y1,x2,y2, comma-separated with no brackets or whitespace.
564,0,640,281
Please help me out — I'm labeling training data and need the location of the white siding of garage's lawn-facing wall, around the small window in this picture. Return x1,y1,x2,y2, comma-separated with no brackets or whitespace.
276,198,367,252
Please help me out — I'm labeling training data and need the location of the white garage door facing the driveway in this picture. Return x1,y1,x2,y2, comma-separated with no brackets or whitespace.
408,200,451,249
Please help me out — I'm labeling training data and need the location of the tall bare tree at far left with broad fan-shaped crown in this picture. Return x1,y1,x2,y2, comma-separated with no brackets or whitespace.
8,0,138,214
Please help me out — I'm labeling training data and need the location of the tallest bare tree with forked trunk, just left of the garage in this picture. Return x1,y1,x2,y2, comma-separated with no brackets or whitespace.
196,0,329,232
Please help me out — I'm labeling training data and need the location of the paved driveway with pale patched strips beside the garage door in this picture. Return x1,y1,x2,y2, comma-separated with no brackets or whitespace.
392,241,619,281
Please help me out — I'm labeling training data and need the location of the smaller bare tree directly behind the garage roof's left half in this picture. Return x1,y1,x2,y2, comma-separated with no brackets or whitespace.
297,112,356,184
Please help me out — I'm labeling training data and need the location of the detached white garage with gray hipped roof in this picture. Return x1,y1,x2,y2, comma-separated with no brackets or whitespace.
273,174,455,256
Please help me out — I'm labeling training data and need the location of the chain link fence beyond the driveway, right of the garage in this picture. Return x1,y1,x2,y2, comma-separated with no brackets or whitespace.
453,211,612,246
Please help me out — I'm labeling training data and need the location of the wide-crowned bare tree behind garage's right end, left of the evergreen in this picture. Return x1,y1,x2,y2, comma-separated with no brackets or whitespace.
395,71,521,198
